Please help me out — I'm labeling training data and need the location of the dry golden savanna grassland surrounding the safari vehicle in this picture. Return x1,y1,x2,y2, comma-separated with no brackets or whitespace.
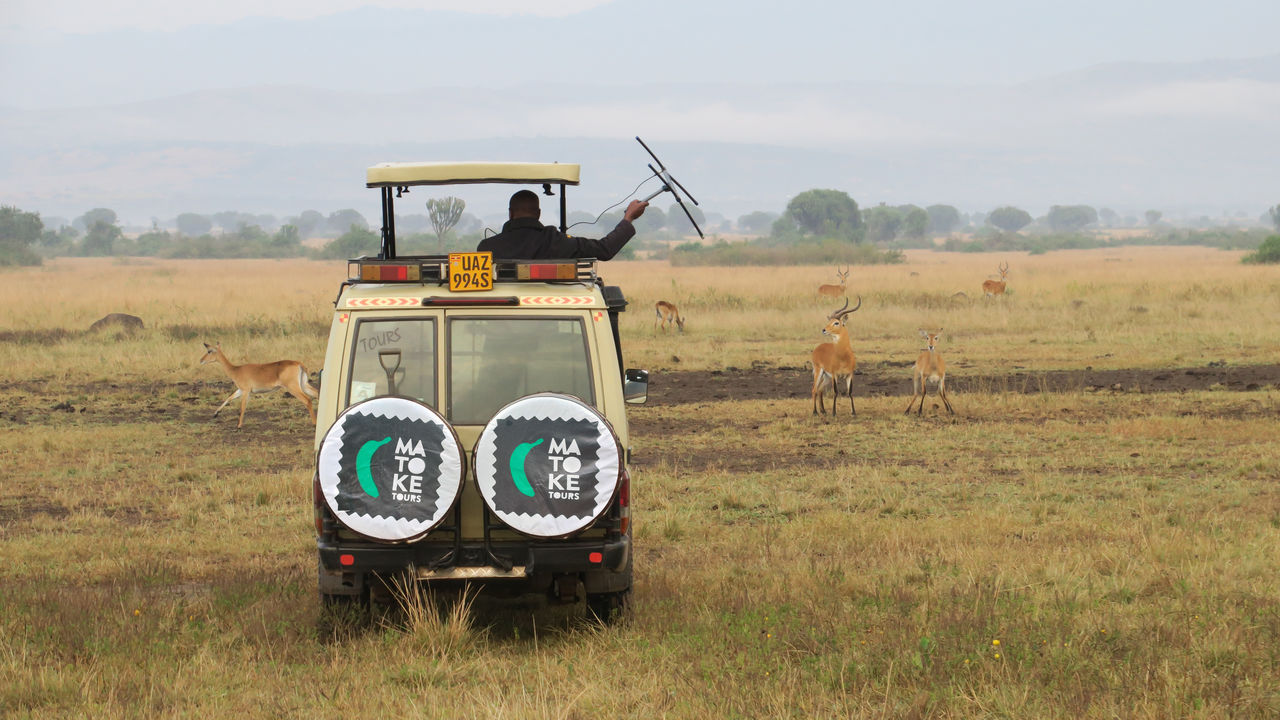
0,249,1280,717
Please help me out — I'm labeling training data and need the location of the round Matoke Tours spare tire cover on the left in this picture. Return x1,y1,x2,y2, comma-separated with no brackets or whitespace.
316,396,463,542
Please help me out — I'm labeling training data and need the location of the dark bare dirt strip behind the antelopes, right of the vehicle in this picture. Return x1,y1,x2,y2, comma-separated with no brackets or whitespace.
649,363,1280,405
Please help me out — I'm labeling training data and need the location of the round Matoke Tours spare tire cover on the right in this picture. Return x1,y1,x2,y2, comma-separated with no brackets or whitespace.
475,393,622,538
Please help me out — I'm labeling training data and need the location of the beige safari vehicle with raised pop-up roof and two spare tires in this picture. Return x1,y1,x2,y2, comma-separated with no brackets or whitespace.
314,163,648,621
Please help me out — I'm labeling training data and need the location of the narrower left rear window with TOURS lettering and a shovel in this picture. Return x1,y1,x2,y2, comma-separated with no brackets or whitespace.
346,318,436,407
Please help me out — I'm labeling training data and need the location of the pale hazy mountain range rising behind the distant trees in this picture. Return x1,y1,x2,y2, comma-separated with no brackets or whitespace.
0,5,1280,223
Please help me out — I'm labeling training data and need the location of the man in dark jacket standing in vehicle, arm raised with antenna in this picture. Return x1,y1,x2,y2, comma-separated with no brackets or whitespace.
476,190,649,260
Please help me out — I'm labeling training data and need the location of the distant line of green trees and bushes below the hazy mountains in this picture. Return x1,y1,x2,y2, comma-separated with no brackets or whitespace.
0,194,1280,265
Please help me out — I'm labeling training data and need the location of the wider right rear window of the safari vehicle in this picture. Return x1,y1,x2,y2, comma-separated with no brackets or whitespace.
449,318,595,425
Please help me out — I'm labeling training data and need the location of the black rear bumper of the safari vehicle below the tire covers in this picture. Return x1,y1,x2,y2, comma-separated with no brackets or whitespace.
316,536,631,579
